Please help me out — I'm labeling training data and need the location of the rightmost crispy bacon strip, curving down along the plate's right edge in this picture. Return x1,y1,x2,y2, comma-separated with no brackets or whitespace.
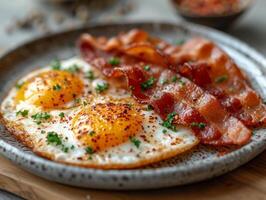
172,38,266,127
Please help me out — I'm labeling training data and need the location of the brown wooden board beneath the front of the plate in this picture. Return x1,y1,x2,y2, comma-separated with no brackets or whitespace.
0,151,266,200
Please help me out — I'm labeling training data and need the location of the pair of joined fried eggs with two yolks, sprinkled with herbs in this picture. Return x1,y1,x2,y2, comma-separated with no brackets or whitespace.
1,58,198,169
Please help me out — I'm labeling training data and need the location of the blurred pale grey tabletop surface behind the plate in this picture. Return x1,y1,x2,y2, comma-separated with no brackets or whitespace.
0,0,266,200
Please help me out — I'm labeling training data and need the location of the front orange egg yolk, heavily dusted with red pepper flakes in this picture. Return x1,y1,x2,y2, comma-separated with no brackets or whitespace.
72,103,143,151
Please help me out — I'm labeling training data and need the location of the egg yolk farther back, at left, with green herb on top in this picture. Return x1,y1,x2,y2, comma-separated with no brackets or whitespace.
15,70,83,109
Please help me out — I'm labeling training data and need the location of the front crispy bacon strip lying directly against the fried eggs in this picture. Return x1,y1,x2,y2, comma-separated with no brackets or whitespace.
80,32,251,145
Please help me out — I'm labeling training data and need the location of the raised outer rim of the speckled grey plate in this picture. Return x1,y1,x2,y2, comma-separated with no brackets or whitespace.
0,22,266,189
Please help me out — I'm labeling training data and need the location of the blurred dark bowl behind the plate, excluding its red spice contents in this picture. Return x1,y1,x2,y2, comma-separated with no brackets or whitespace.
172,0,254,29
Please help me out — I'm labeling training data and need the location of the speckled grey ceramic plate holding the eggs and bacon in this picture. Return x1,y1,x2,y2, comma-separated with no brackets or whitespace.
0,23,266,189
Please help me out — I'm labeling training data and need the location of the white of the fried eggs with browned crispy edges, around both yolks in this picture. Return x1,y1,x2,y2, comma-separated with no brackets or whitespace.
1,58,198,169
